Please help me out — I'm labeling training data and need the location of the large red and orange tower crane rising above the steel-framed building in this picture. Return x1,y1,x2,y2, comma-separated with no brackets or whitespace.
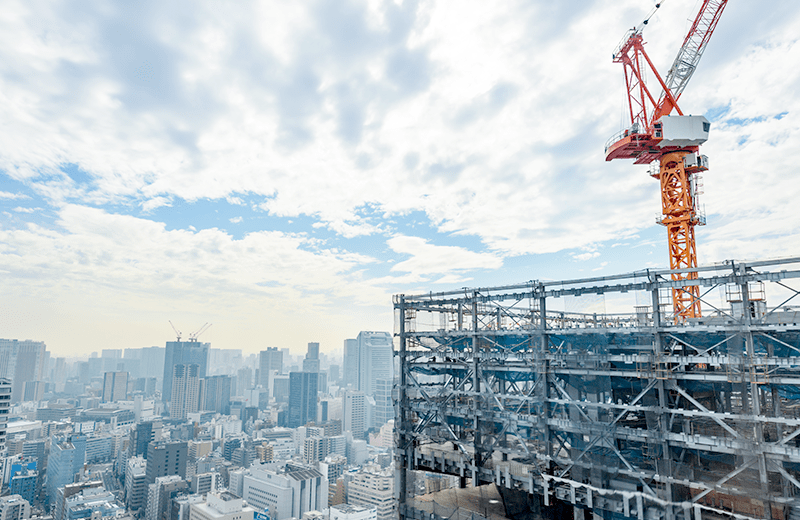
605,0,728,322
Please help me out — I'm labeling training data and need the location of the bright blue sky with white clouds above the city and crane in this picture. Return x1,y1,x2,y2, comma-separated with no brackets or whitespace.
0,0,800,356
